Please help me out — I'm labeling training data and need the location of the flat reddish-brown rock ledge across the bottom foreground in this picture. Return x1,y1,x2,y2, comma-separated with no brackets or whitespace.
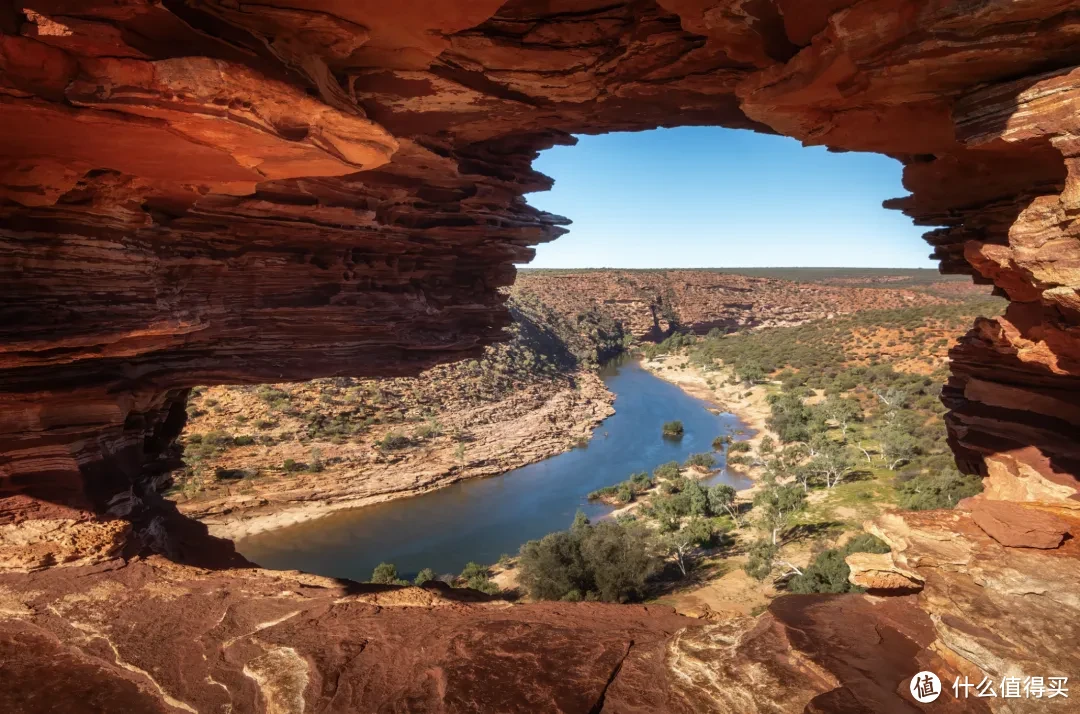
0,556,985,714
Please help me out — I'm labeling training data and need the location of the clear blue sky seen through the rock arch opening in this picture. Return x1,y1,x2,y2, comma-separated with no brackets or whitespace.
518,127,936,268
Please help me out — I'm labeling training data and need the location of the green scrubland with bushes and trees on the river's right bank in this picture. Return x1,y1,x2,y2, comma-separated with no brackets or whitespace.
453,299,1000,602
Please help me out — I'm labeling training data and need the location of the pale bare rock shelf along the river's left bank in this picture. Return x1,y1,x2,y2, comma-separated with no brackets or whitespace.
178,372,615,540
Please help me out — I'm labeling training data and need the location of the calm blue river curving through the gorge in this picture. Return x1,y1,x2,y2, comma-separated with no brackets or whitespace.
237,361,748,580
